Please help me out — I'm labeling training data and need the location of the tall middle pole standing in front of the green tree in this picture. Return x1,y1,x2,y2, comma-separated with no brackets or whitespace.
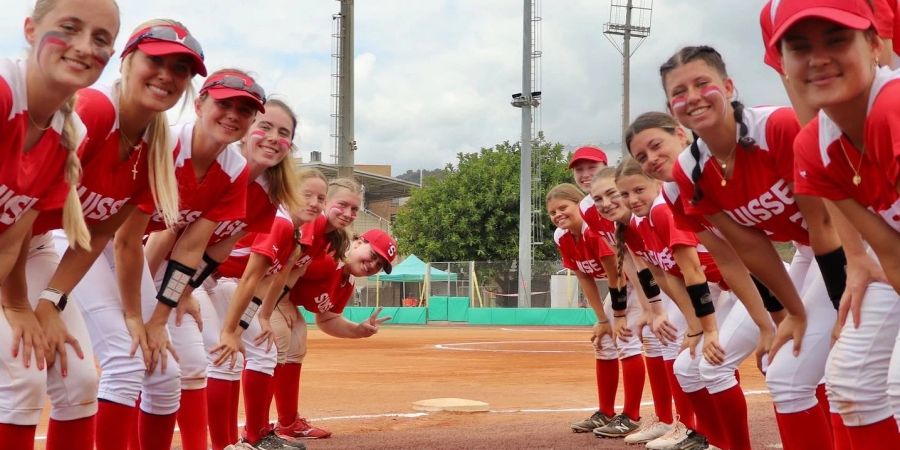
512,0,541,308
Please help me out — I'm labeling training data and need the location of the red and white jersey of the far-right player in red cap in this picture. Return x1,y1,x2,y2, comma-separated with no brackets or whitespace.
794,68,900,231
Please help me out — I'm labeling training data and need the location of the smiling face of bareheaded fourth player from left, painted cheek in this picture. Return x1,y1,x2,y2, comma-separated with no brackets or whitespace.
244,106,294,168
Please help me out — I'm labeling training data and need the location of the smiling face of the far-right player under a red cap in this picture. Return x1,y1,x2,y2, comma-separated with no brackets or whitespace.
781,19,883,114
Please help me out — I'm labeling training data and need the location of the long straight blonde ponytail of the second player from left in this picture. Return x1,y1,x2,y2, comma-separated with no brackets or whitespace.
147,112,178,227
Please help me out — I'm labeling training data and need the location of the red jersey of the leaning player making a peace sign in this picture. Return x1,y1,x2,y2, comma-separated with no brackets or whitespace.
290,253,356,314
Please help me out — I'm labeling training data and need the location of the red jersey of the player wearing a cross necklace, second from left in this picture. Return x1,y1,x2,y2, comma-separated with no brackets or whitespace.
34,85,156,234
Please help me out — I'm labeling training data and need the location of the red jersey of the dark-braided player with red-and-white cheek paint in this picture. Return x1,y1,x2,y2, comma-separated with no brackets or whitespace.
673,107,809,245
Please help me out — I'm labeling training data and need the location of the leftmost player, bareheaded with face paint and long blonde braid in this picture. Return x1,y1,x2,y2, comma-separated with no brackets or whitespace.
0,0,119,450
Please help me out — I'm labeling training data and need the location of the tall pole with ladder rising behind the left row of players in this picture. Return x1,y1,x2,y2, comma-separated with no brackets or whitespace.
331,0,356,177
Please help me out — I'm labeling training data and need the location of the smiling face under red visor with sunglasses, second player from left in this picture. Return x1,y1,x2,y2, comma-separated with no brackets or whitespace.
122,50,193,112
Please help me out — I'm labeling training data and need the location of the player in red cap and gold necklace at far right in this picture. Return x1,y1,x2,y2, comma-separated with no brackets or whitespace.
768,0,900,448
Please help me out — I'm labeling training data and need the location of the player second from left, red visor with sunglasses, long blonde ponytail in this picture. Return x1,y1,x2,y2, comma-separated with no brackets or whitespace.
28,20,205,449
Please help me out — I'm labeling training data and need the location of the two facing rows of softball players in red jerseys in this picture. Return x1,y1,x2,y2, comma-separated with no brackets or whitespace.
0,0,900,450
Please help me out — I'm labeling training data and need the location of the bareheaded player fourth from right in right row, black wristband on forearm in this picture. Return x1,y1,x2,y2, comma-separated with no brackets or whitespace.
616,158,772,449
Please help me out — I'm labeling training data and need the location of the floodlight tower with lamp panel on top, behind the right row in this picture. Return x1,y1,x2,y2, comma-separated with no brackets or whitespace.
603,0,653,146
